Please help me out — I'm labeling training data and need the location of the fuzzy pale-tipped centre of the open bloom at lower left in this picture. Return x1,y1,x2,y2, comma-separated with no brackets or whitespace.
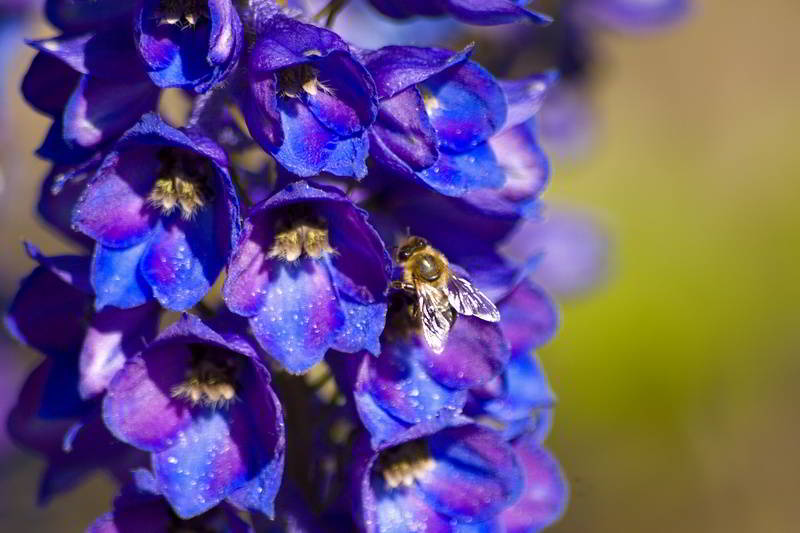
170,357,236,409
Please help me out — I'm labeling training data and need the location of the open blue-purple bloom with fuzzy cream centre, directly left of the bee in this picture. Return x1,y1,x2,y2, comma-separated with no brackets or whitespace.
223,181,391,373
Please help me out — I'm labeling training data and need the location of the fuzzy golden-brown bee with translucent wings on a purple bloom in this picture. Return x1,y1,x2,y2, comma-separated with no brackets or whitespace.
392,236,500,353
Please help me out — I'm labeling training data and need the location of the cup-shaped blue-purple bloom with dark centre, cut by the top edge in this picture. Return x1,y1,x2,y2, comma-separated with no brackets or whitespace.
136,0,244,93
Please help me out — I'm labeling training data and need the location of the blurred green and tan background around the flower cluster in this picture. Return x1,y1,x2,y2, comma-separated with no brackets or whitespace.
0,0,800,533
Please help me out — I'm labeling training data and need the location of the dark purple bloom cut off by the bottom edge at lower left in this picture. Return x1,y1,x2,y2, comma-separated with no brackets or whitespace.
87,470,253,533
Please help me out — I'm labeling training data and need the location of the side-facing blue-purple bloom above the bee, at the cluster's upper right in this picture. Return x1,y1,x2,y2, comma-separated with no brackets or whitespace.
365,46,554,216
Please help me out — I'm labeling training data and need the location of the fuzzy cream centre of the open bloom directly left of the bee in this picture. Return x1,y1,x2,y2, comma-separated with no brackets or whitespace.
267,218,336,262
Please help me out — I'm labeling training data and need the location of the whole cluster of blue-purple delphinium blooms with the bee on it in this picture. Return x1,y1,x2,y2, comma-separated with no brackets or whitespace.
6,0,684,533
